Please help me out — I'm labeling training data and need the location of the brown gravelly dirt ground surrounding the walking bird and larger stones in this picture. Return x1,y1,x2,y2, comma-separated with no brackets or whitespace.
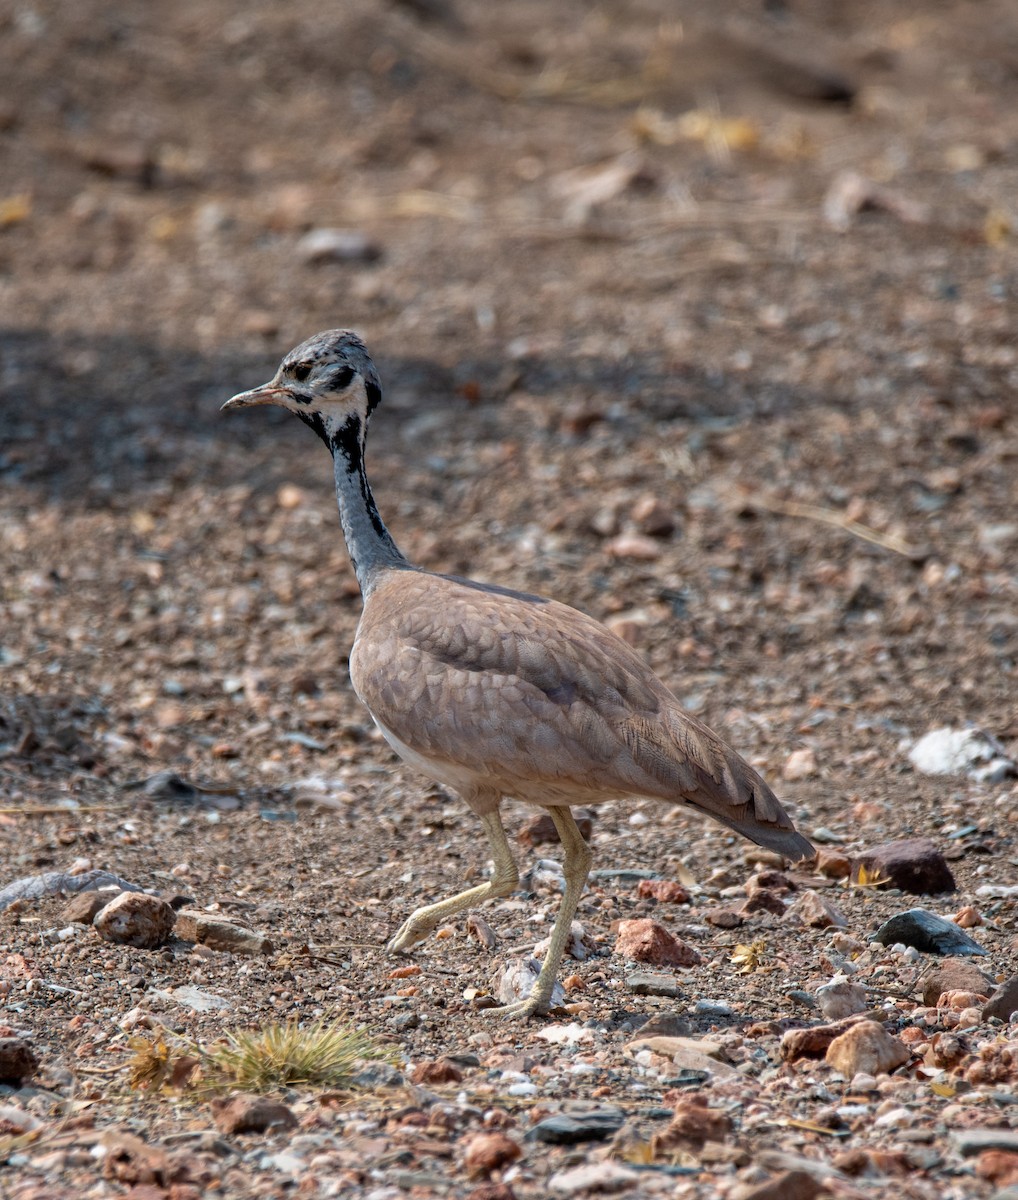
0,0,1018,1200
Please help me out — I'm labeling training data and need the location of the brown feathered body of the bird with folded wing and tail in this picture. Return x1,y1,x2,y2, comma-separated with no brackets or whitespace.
351,572,812,858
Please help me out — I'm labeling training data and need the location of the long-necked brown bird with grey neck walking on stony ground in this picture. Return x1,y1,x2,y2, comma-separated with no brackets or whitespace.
222,329,815,1018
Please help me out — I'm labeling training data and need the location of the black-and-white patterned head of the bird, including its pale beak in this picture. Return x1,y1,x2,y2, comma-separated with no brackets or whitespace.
222,329,382,450
